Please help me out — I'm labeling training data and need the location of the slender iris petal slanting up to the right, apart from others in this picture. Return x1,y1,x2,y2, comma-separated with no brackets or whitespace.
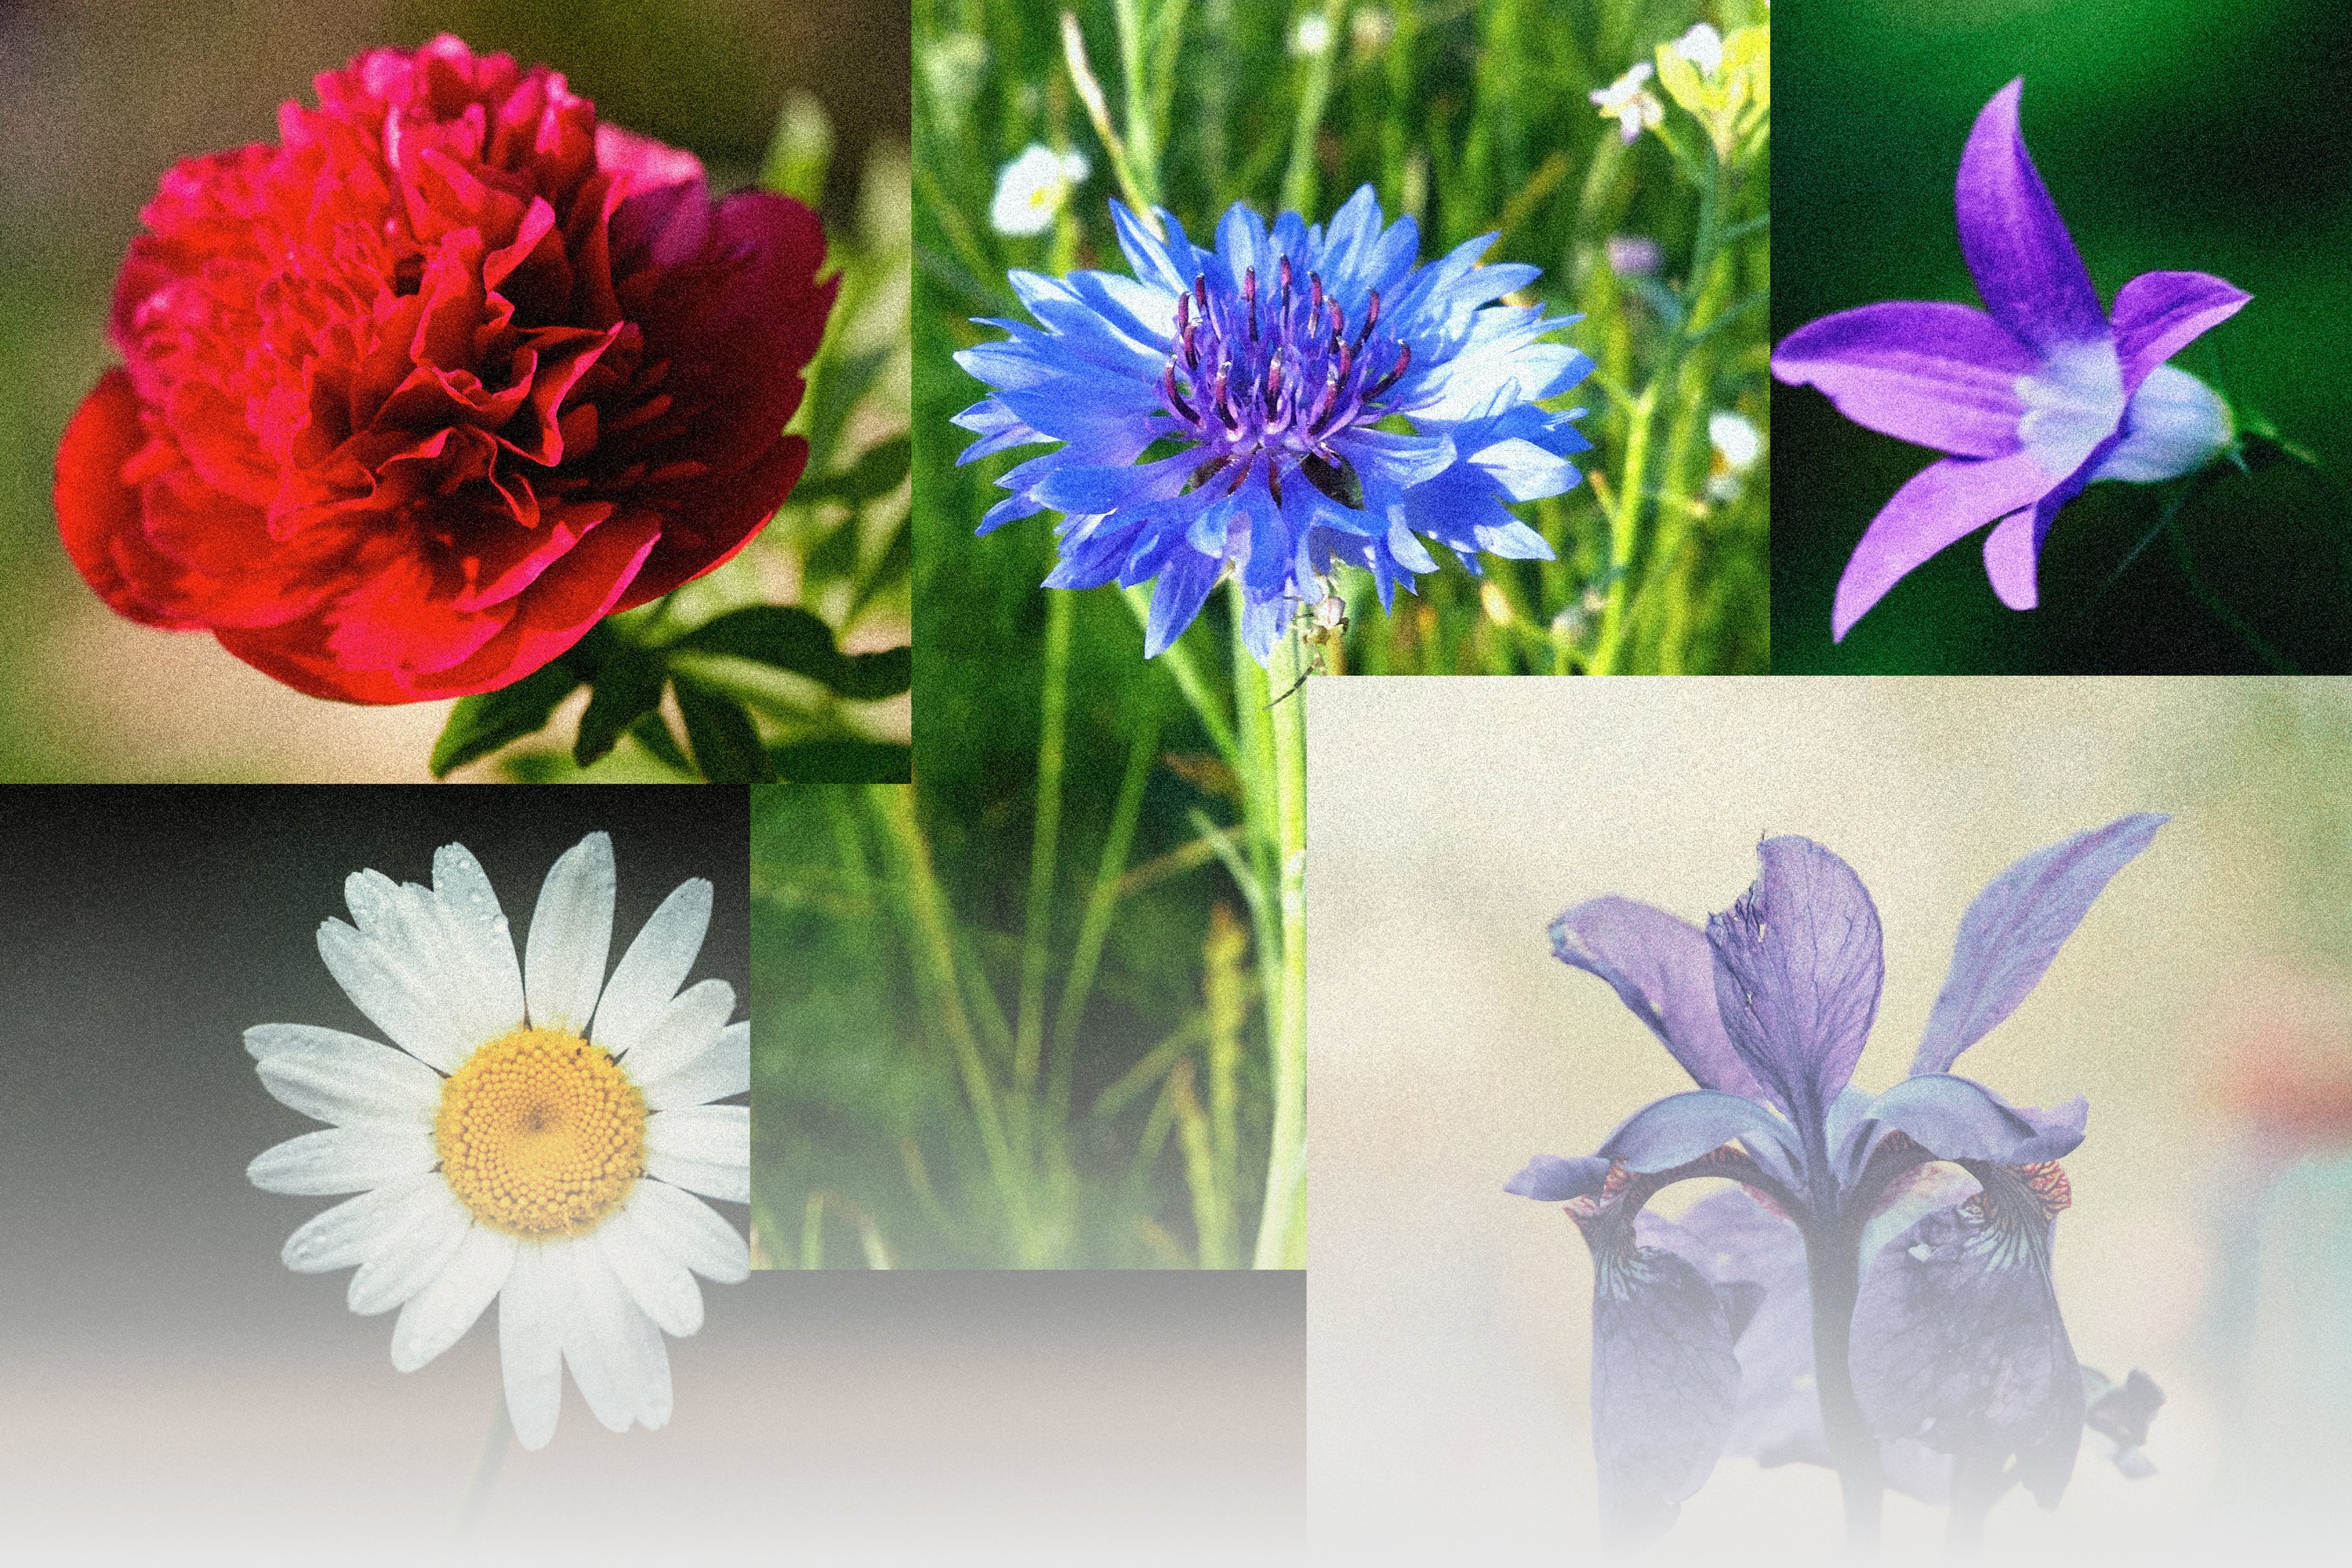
1912,818,2171,1072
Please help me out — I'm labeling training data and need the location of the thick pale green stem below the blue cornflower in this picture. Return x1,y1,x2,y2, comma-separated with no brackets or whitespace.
1254,635,1308,1269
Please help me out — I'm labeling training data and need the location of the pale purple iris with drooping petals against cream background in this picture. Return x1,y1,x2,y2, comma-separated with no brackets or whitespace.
1505,813,2169,1537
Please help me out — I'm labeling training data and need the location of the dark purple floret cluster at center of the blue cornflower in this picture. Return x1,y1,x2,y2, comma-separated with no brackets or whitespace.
1160,256,1414,501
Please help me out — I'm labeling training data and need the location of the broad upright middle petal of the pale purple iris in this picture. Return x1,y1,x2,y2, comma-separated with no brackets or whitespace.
1708,834,1886,1126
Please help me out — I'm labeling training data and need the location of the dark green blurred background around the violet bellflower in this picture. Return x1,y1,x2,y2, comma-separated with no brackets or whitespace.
1771,0,2352,675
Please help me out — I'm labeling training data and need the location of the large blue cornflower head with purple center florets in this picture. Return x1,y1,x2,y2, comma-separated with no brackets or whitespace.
955,186,1592,663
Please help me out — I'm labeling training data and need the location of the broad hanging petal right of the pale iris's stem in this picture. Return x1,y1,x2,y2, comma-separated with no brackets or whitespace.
1851,1166,2084,1507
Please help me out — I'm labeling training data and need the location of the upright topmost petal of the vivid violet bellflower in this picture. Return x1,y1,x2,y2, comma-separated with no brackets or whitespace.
1957,78,2110,353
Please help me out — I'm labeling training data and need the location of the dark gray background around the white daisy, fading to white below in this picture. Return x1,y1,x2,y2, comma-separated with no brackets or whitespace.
0,787,1305,1561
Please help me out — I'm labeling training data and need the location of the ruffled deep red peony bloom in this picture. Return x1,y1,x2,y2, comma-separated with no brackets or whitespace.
56,38,835,703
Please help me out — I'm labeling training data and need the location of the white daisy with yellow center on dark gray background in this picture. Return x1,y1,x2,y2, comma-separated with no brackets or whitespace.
245,832,750,1448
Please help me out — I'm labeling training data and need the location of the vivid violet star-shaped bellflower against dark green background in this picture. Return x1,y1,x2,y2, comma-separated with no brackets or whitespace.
1771,78,2249,640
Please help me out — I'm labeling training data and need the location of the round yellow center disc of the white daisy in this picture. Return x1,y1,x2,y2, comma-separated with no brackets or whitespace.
433,1029,644,1239
